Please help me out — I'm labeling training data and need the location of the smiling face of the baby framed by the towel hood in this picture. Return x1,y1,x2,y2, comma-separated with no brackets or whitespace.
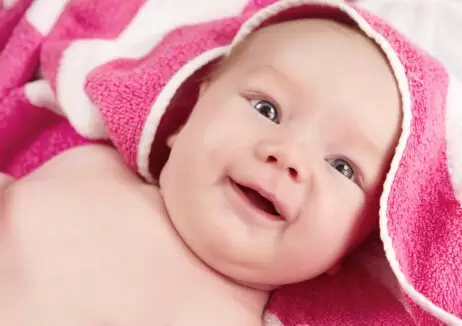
160,20,400,288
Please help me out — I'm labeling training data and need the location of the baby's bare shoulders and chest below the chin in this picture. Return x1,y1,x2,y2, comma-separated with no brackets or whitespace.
0,146,266,326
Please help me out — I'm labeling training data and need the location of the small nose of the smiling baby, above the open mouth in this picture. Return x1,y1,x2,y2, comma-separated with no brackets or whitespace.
256,142,306,182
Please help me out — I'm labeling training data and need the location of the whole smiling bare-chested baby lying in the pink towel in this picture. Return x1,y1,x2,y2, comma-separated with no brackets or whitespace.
0,19,401,326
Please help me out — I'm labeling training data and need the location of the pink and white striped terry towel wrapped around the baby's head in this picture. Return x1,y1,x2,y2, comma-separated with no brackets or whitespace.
0,0,462,325
